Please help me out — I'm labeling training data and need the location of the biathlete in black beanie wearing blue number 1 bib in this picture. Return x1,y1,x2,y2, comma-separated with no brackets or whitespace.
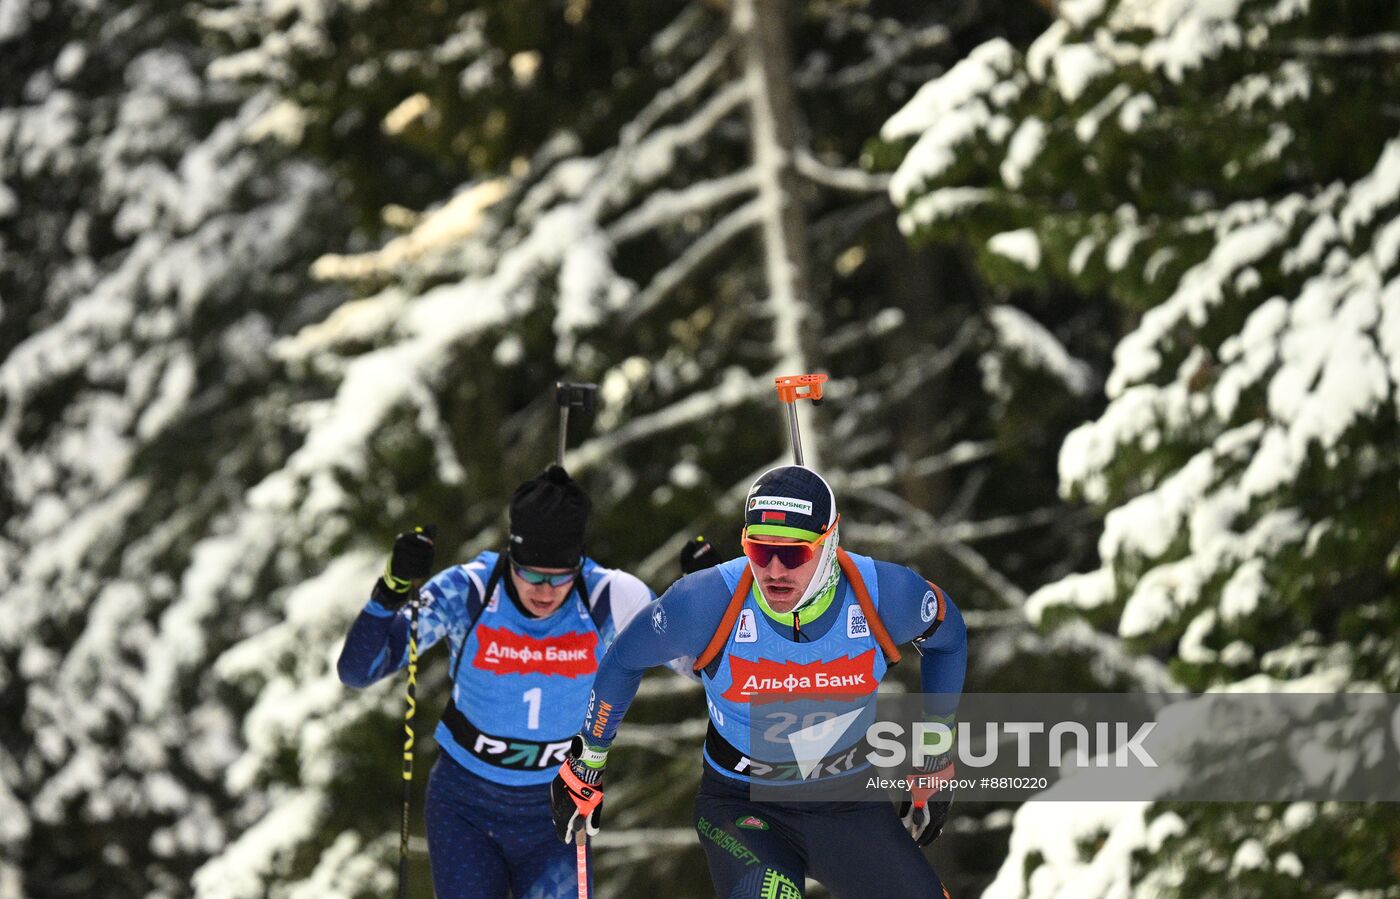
339,466,655,899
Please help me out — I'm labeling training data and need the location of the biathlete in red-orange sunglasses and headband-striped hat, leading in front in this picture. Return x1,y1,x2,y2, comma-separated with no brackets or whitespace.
552,465,967,899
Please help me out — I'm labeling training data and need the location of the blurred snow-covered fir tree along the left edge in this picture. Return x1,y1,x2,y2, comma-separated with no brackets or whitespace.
0,3,355,896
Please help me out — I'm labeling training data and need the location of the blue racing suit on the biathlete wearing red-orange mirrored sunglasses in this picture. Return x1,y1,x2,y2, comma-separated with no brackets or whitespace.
584,555,967,899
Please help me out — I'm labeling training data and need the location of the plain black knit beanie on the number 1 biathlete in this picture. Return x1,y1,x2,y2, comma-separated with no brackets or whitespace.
511,465,592,569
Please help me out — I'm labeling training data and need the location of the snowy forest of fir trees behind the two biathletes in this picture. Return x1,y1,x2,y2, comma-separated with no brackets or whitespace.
0,0,1400,899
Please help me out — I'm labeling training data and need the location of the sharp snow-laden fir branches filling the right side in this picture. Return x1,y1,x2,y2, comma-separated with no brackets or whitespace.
882,0,1400,898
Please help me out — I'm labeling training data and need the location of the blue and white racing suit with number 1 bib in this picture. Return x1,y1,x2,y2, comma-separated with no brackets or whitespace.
339,553,655,899
